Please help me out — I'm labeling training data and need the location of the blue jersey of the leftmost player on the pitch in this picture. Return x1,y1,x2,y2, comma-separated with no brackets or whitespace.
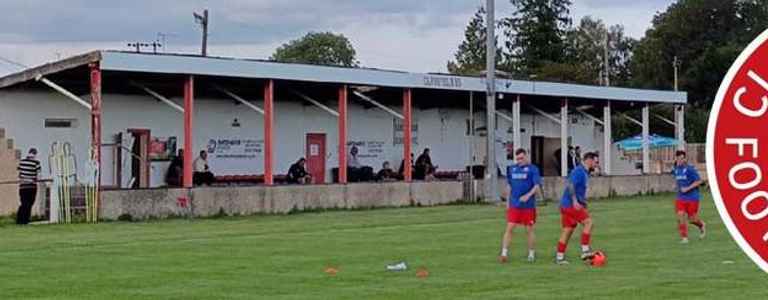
507,164,541,208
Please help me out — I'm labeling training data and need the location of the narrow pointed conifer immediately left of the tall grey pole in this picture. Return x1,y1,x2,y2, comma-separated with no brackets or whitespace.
448,7,501,75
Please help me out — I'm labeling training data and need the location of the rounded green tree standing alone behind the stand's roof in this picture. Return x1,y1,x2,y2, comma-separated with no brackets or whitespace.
270,32,359,67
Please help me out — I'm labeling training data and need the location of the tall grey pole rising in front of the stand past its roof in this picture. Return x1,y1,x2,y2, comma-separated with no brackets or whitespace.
485,0,499,202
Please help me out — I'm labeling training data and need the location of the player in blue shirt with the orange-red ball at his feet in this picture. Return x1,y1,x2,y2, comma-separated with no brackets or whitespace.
555,152,599,264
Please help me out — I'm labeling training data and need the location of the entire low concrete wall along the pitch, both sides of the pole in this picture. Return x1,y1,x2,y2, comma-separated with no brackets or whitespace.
100,175,674,220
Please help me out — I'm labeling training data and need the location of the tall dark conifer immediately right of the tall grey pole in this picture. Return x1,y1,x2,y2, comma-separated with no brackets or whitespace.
502,0,571,77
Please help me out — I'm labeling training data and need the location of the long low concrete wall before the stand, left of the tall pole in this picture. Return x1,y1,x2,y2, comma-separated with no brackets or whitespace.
100,182,436,220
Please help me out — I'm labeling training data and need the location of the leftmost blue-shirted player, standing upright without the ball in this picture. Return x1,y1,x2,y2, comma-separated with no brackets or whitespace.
499,149,541,263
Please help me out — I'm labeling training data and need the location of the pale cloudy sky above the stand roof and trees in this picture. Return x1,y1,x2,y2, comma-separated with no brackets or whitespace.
0,0,673,75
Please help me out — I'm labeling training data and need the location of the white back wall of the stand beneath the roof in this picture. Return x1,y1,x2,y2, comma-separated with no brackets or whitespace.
0,91,618,186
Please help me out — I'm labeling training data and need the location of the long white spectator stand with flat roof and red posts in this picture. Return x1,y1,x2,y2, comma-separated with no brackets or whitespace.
0,51,686,188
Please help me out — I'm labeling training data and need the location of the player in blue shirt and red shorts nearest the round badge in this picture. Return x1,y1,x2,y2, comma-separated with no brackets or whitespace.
673,151,707,244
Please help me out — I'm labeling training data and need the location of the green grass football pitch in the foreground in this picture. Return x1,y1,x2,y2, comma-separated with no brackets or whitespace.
0,195,768,300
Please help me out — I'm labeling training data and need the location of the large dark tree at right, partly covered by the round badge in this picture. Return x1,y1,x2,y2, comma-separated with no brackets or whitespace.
631,0,768,142
